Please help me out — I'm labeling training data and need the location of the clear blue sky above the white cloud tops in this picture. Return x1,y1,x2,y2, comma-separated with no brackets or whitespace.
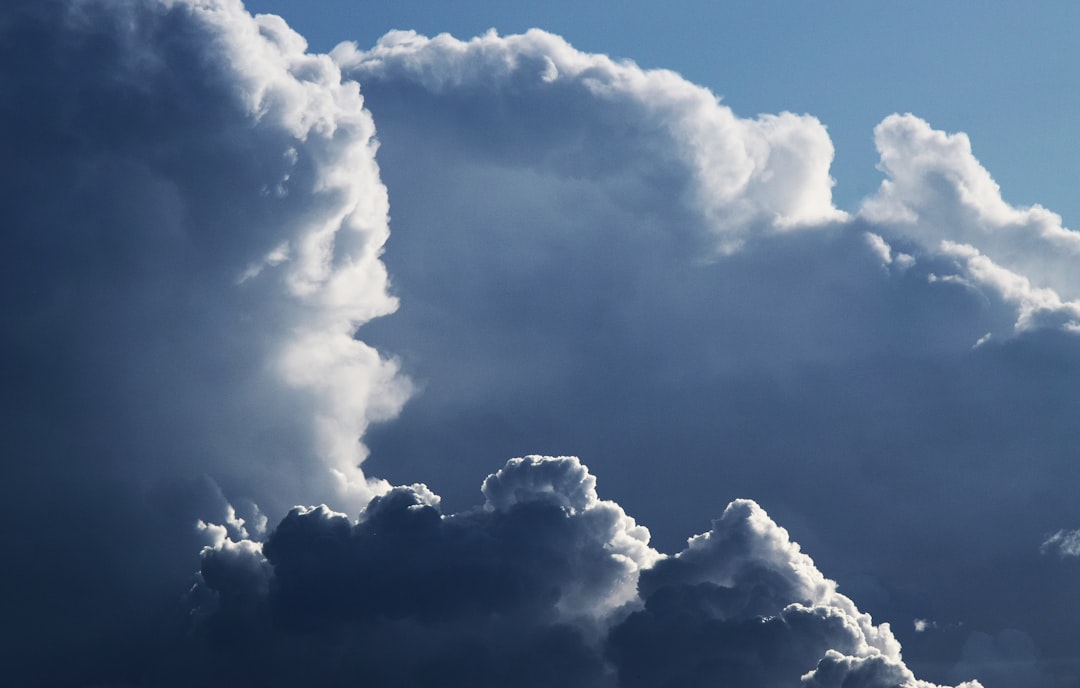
245,0,1080,229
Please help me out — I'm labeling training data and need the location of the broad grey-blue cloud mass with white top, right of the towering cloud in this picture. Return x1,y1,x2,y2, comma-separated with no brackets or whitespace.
334,24,1080,683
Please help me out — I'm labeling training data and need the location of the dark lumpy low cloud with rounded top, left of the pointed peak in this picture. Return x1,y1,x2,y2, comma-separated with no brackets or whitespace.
200,457,659,686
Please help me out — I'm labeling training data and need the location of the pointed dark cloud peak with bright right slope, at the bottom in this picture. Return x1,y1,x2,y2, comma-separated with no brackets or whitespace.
610,500,978,688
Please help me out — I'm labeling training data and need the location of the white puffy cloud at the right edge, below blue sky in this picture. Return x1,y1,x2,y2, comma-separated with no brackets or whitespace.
860,114,1080,329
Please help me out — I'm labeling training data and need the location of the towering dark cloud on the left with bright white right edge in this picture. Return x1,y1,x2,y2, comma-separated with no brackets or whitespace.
0,0,409,670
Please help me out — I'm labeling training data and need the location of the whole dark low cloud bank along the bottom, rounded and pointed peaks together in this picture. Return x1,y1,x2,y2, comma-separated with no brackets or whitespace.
194,456,977,688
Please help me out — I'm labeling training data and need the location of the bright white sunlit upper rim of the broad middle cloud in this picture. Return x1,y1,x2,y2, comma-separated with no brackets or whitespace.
333,29,846,253
